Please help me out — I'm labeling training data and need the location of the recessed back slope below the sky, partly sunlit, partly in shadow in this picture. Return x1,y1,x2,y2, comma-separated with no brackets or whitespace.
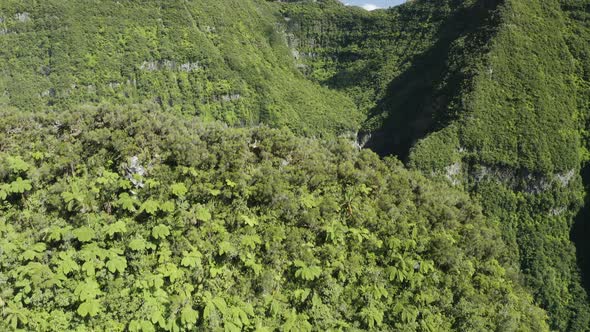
283,0,499,159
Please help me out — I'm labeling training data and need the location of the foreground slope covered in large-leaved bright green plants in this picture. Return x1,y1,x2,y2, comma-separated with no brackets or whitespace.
0,107,548,332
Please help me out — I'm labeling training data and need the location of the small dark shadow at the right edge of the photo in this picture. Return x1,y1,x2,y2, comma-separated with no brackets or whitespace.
571,165,590,294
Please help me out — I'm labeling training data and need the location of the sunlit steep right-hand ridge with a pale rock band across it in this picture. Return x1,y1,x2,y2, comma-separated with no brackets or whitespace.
413,1,590,331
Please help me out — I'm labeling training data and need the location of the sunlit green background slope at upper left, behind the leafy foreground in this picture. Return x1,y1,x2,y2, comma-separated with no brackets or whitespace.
0,0,359,135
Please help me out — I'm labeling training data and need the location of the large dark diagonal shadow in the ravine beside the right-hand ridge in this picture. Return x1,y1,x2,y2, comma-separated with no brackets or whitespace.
367,0,502,161
